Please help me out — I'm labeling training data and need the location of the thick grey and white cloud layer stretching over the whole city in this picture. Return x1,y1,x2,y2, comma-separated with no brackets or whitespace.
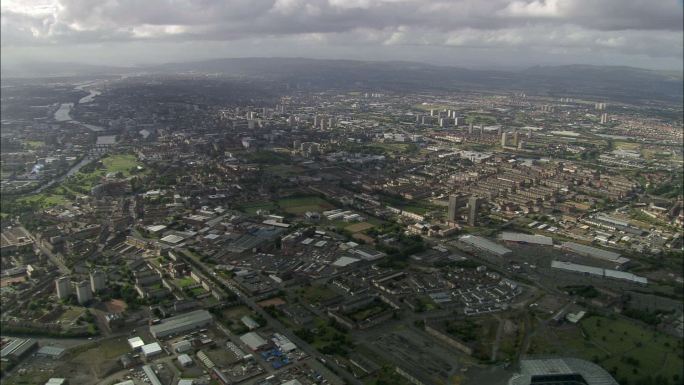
1,0,682,69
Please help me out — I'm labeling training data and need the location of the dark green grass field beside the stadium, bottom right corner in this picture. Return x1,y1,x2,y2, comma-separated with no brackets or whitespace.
532,316,684,385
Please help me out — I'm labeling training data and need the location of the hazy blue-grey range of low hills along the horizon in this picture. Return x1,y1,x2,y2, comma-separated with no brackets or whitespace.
2,58,684,102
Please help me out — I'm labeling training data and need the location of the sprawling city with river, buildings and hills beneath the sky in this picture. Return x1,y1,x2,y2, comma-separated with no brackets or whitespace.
0,2,684,385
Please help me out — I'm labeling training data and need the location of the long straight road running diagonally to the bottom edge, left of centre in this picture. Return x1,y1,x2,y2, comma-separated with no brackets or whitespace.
183,248,362,385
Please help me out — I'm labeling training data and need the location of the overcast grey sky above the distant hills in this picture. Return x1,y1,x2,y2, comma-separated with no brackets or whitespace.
1,0,683,71
